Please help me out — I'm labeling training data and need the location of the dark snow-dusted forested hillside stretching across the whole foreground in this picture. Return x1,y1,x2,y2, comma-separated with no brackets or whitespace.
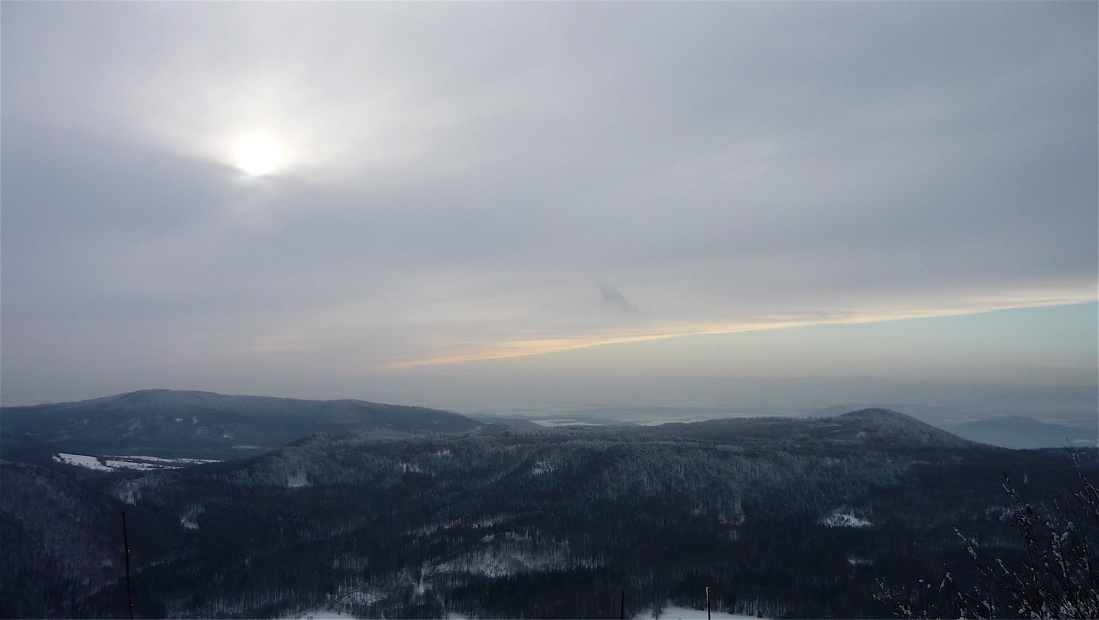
2,410,1097,618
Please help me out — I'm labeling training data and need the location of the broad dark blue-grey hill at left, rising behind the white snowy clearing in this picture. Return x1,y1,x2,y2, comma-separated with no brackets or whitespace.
0,389,485,460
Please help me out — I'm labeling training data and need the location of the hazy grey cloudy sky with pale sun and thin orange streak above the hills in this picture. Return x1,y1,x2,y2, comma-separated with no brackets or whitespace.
0,1,1099,408
